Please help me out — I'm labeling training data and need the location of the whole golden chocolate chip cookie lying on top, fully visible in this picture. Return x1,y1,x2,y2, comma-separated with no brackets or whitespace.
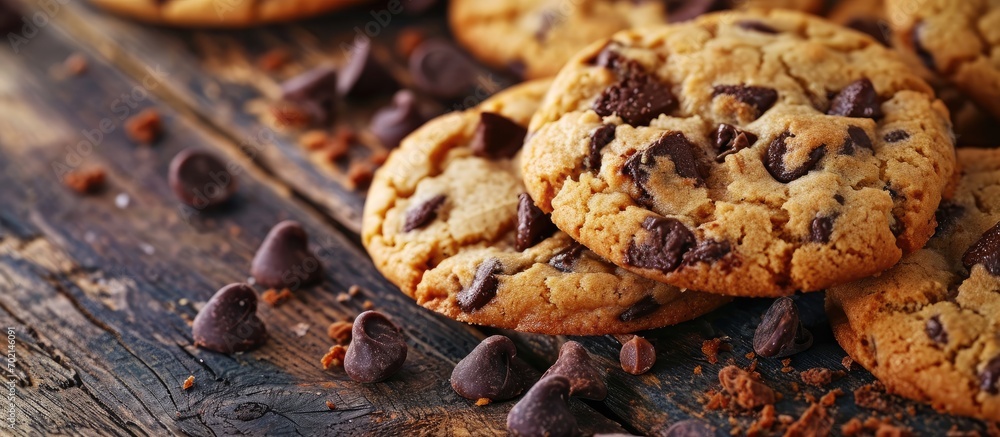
523,11,955,296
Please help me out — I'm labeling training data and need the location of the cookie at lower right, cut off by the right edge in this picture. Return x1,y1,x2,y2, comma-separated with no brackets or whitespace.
826,149,1000,421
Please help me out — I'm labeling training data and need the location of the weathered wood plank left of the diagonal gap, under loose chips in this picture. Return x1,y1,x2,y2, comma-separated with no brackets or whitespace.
0,17,621,435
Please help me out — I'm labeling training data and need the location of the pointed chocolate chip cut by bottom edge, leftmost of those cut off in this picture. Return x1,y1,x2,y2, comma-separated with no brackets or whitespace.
507,375,580,437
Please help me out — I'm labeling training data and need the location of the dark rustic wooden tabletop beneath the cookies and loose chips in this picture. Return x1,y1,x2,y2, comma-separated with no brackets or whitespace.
0,1,986,435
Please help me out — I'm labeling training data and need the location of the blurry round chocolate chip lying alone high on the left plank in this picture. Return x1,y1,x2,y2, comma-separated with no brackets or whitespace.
167,149,236,209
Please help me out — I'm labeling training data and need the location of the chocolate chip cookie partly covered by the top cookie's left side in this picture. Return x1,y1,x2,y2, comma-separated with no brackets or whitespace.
362,82,727,335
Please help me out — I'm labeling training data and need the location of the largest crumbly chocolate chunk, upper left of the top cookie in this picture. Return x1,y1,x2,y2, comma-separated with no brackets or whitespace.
594,61,677,126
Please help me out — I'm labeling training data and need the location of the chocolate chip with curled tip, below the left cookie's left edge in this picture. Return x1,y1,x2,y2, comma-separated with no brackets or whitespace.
344,311,407,383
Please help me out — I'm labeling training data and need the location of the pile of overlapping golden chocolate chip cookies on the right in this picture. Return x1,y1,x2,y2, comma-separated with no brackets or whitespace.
362,0,1000,428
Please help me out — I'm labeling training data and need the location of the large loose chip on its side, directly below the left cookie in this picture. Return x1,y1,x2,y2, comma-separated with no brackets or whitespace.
451,335,537,401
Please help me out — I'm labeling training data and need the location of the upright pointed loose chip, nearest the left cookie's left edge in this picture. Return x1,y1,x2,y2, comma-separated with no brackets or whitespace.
250,220,323,291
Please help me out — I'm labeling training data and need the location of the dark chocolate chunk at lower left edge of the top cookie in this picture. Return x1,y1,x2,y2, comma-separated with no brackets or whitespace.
625,216,695,273
